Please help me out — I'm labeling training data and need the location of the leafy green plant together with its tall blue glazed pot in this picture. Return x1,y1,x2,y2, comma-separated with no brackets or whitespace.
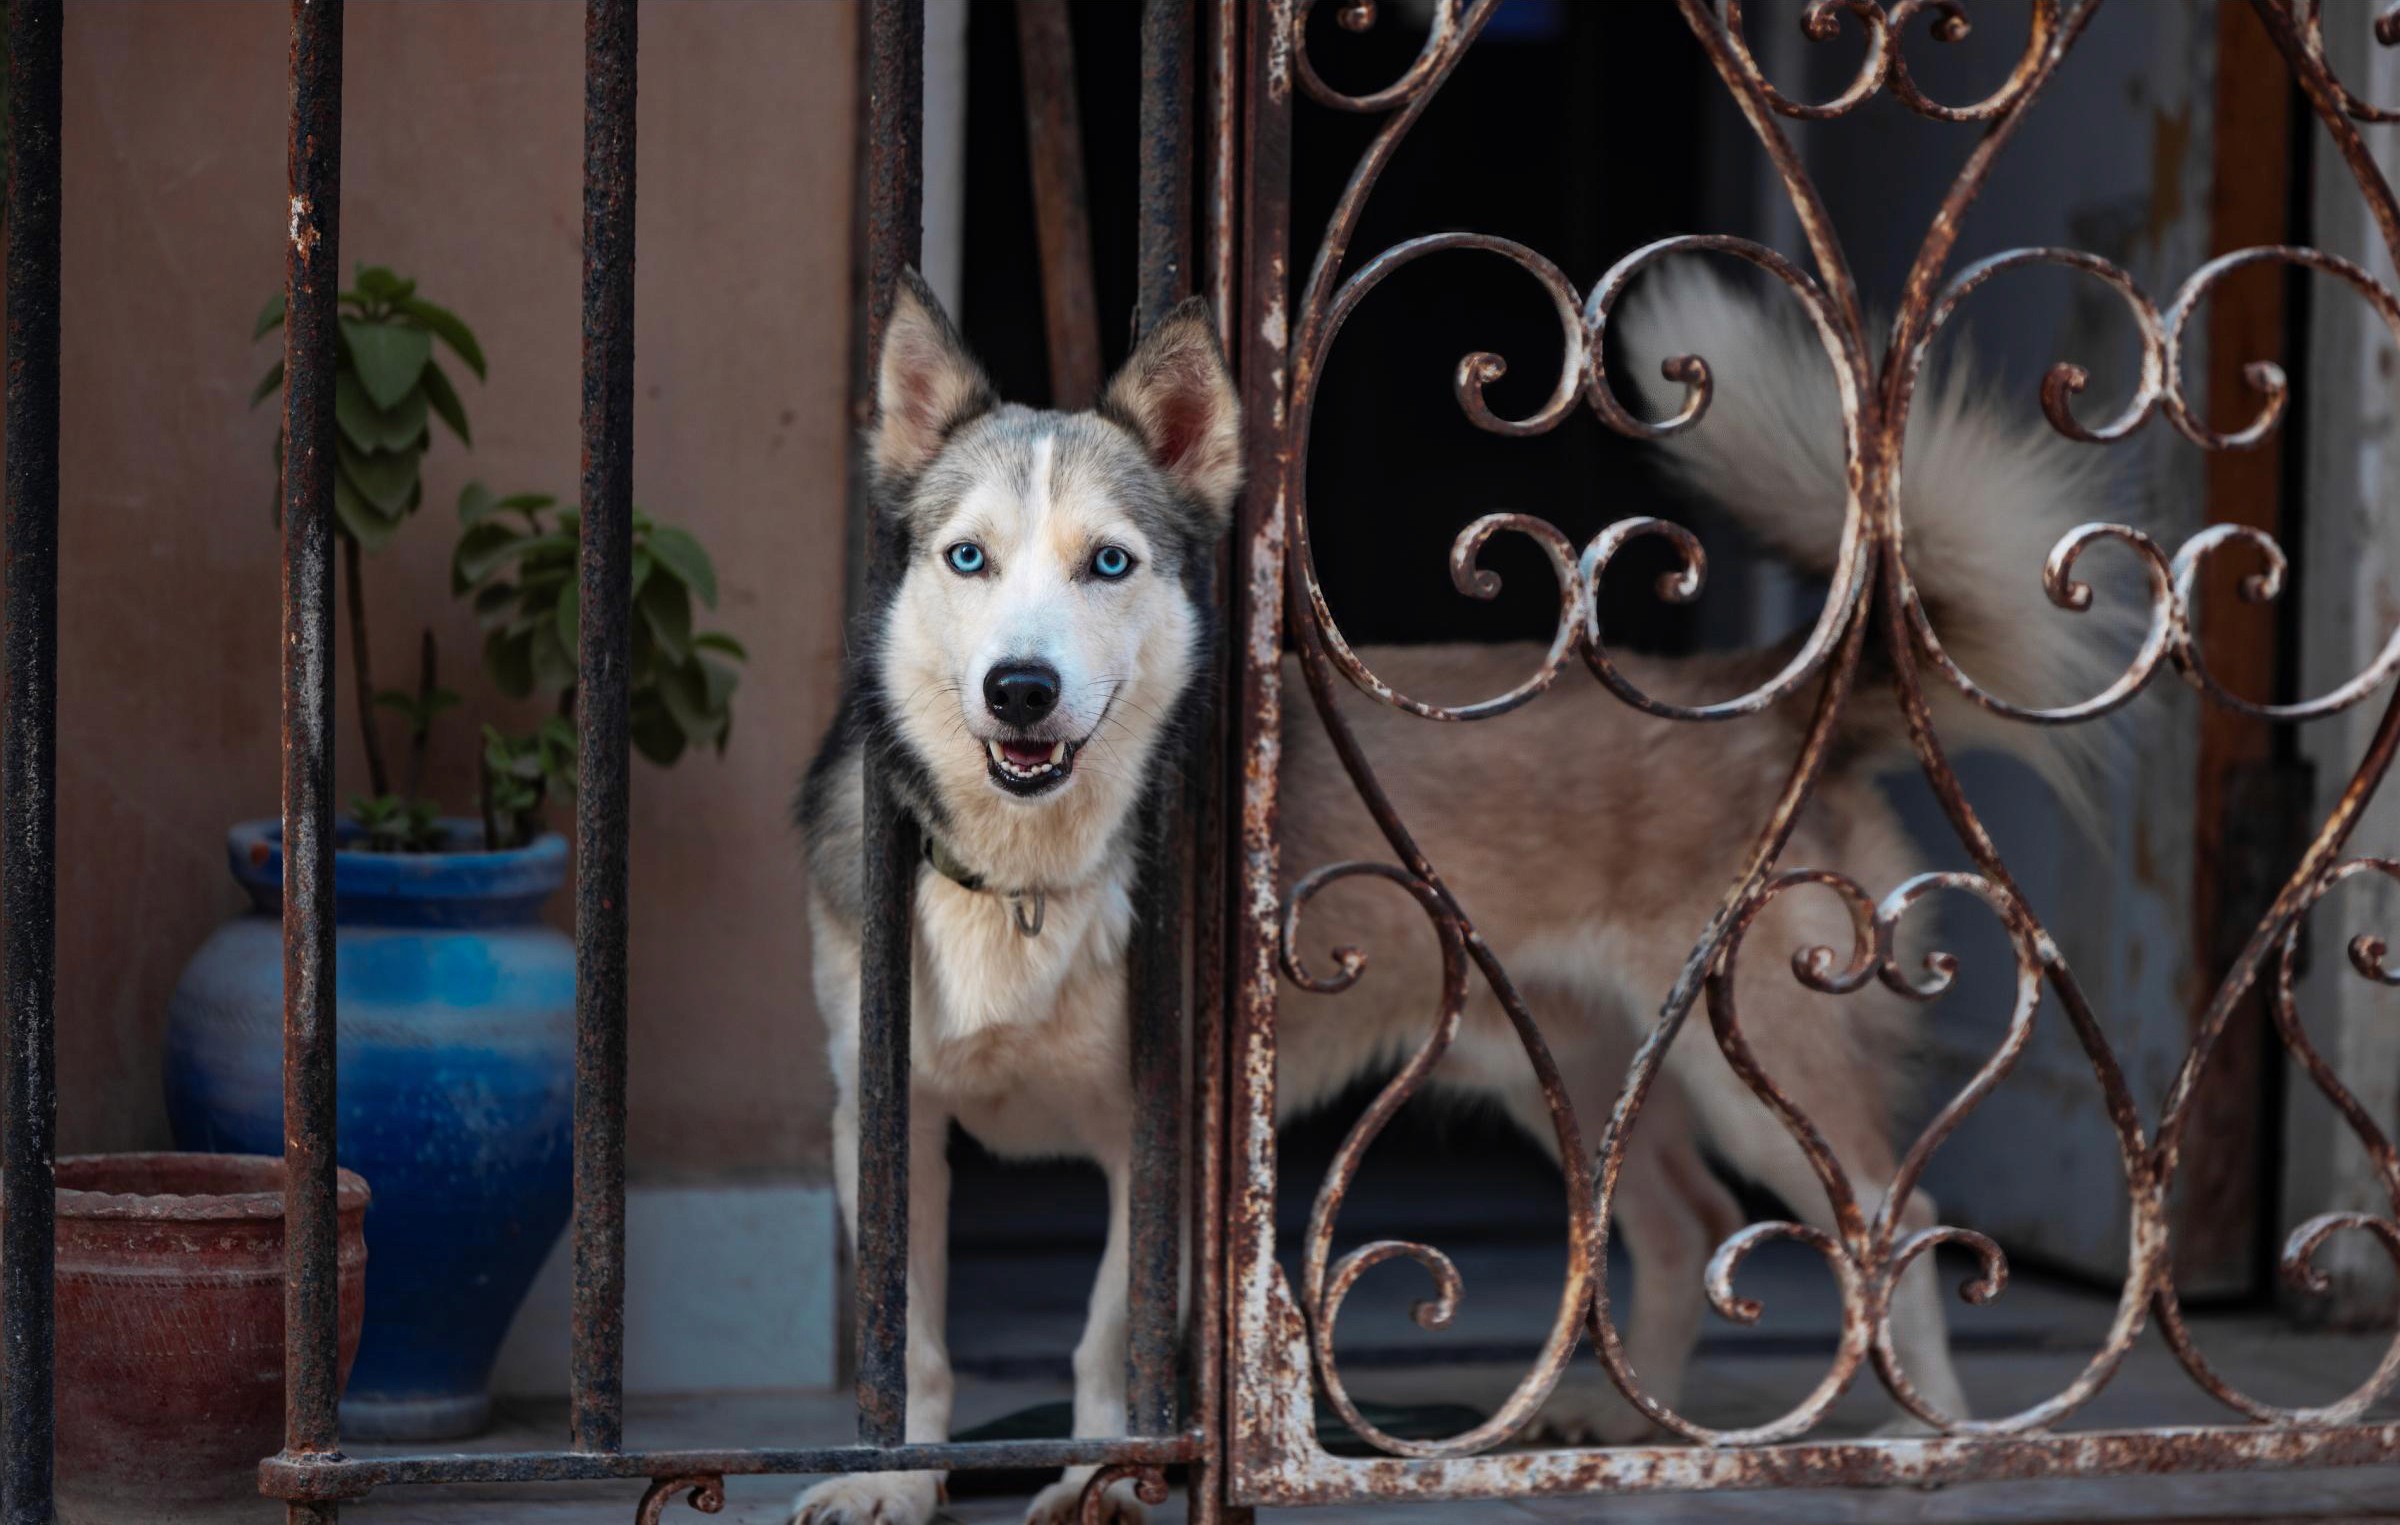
168,267,744,1441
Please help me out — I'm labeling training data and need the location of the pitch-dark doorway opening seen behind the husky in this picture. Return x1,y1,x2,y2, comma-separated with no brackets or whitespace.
950,0,1709,1374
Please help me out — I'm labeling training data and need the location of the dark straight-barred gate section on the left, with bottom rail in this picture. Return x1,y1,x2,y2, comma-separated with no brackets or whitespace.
0,0,1207,1525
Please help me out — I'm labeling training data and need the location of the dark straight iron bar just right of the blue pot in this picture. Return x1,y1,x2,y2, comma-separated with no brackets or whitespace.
569,0,641,1451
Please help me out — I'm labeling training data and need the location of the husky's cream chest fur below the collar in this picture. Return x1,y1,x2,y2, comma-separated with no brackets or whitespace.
912,865,1133,1155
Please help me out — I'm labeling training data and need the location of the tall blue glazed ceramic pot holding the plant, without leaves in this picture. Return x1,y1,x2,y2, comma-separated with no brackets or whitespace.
166,821,576,1441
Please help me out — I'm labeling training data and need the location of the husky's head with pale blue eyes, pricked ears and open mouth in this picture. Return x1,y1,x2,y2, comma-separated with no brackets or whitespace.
869,268,1241,869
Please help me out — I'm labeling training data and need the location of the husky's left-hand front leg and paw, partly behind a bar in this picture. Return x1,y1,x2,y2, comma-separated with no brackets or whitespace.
792,1093,955,1525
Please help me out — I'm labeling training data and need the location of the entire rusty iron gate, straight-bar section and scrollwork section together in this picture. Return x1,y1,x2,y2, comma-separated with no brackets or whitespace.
0,0,2400,1525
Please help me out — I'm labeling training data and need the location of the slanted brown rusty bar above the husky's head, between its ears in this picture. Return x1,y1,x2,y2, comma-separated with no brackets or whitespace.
1018,0,1099,408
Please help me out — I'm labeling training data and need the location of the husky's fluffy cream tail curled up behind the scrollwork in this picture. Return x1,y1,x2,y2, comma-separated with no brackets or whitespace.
1618,262,2143,814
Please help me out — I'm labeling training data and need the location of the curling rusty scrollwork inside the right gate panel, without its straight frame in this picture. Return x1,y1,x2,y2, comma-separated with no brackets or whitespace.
1279,0,2400,1465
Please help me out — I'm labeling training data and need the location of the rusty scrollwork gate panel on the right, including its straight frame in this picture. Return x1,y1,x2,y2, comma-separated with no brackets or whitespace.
1202,0,2400,1506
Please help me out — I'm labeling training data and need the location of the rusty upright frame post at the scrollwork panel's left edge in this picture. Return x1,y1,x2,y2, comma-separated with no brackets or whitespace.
1222,0,1294,1520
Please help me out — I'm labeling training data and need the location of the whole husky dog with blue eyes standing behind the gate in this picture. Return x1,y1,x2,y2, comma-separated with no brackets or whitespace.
794,271,2105,1525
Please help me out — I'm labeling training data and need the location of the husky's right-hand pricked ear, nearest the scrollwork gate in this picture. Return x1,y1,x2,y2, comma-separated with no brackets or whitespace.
1099,298,1241,531
